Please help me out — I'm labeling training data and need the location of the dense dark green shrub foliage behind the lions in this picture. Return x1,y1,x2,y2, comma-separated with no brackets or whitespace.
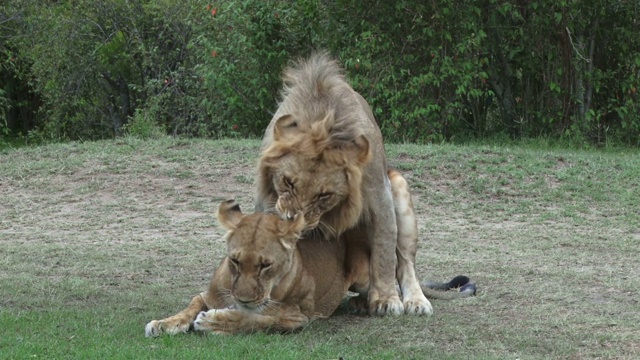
0,0,640,146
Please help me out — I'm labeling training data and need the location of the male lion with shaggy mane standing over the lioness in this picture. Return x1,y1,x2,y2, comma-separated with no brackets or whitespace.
256,53,424,315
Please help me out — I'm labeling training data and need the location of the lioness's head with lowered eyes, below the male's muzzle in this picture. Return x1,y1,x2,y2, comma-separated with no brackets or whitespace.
218,200,304,310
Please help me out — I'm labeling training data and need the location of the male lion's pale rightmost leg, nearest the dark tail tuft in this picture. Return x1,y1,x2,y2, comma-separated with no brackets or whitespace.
388,170,433,315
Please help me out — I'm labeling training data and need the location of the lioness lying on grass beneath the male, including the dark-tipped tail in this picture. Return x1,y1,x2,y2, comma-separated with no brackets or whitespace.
145,200,475,337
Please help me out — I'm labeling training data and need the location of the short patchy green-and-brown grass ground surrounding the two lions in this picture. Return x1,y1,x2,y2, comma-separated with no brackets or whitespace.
0,138,640,359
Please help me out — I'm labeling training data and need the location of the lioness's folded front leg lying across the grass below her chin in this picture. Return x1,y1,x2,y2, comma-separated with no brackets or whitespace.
193,306,309,334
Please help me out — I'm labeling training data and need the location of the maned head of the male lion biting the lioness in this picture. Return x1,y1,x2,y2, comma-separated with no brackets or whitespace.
259,113,371,233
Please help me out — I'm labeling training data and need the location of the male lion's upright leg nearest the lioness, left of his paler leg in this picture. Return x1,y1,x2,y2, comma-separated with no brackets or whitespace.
369,180,404,315
